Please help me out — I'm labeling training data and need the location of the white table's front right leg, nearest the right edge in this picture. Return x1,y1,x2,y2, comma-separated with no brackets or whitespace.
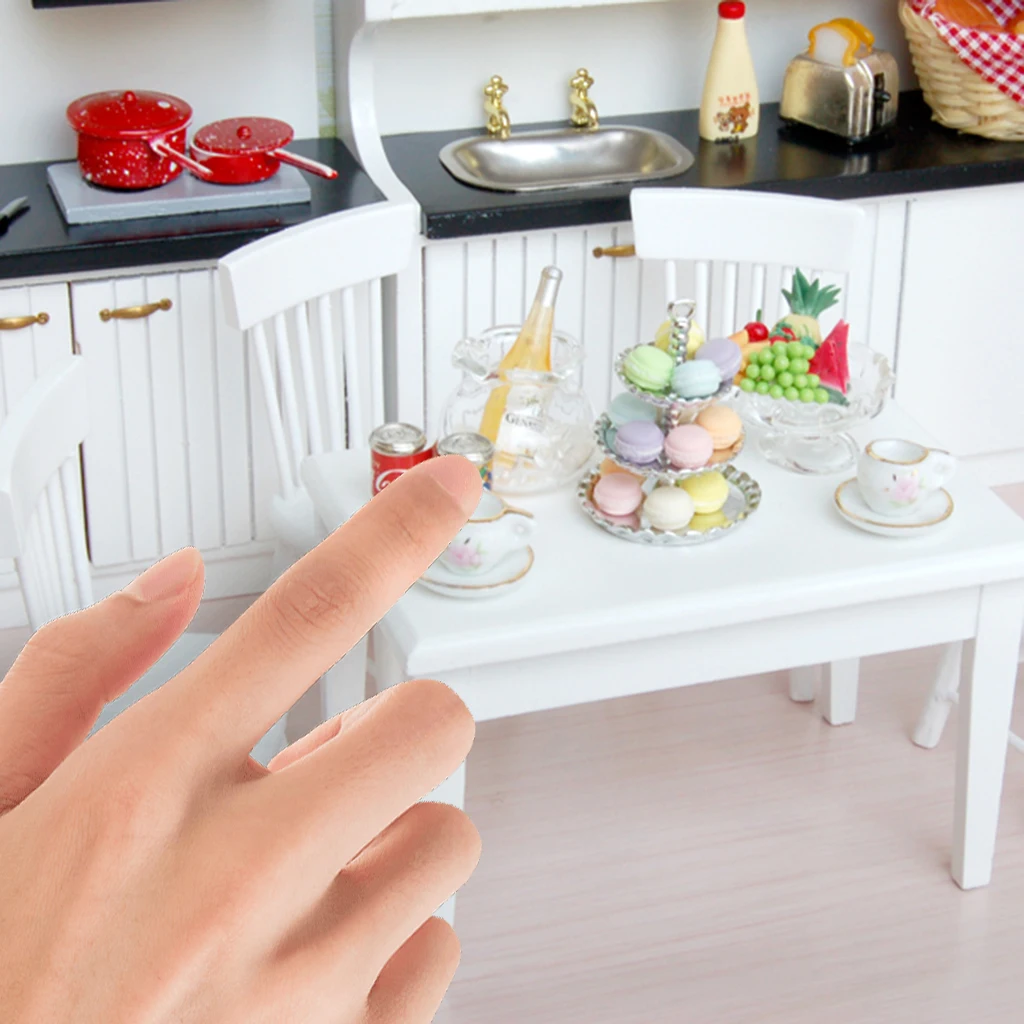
952,581,1024,889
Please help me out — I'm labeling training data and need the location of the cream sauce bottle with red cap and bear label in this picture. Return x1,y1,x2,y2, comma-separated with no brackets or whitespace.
699,0,761,142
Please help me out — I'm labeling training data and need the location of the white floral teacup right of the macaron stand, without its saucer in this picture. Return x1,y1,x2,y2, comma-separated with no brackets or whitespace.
857,438,956,519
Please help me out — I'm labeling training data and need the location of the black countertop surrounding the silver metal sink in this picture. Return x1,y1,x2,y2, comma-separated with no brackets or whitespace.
384,91,1024,239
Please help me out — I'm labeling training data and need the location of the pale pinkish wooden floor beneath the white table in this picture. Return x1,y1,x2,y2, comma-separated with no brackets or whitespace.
0,486,1024,1024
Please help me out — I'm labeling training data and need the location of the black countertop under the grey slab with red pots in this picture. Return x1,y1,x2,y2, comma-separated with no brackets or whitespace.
0,138,384,279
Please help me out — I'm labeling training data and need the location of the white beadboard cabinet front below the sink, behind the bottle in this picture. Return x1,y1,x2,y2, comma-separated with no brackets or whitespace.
423,203,884,432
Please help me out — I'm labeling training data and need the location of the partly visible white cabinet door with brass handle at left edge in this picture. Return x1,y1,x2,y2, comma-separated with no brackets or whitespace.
0,284,72,419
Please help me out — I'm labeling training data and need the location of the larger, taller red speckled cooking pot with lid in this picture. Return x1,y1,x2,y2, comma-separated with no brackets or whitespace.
68,91,211,188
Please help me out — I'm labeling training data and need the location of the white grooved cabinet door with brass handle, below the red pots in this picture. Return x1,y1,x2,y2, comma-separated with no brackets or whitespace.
72,270,276,565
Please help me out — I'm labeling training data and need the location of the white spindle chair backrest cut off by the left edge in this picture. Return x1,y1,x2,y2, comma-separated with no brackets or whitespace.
0,355,92,630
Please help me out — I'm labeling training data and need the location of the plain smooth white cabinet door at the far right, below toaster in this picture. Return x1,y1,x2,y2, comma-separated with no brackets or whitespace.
896,185,1024,468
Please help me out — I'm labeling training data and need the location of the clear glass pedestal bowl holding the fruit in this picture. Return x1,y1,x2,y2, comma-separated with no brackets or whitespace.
734,342,896,473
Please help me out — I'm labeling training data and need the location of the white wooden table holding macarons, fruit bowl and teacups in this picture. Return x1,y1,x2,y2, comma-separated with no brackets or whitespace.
303,406,1024,901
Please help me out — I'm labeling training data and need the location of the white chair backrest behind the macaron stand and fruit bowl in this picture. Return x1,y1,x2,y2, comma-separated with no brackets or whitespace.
630,188,870,335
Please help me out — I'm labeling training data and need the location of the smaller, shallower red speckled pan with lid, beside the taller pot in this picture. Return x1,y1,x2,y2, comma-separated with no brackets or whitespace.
189,118,338,185
